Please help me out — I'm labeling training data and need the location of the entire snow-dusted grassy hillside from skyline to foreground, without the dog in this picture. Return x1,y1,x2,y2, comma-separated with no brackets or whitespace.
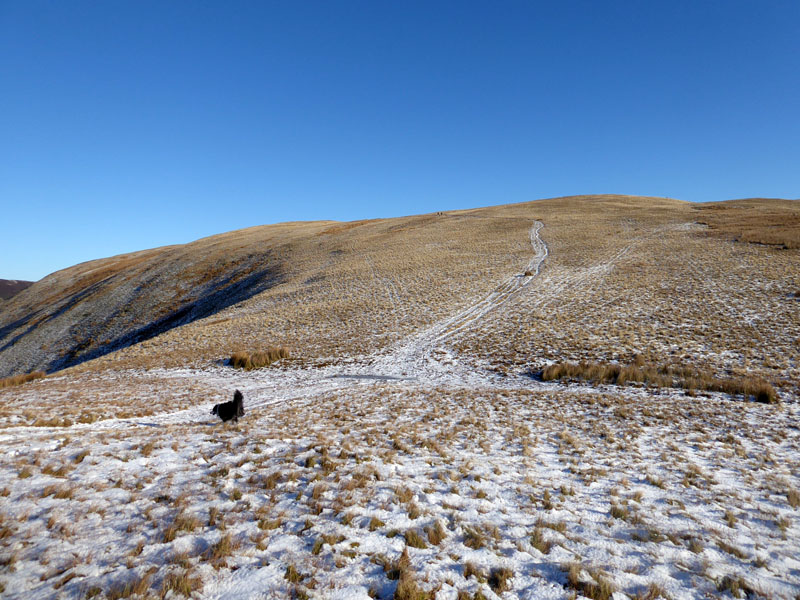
0,195,800,600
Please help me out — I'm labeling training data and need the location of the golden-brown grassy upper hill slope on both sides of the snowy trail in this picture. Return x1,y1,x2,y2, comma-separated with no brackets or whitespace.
0,196,800,396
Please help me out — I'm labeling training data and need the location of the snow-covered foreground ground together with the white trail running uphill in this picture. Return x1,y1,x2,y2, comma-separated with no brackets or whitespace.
0,223,800,600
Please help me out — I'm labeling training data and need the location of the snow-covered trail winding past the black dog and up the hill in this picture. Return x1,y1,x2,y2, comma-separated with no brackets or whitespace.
0,221,548,443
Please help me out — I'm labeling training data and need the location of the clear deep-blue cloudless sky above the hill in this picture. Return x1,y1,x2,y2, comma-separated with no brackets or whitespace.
0,0,800,280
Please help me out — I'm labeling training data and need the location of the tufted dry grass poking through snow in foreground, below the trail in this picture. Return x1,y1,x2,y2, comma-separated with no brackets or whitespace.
3,384,798,598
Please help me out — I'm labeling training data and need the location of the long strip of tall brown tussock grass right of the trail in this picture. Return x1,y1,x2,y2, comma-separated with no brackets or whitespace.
541,361,778,404
